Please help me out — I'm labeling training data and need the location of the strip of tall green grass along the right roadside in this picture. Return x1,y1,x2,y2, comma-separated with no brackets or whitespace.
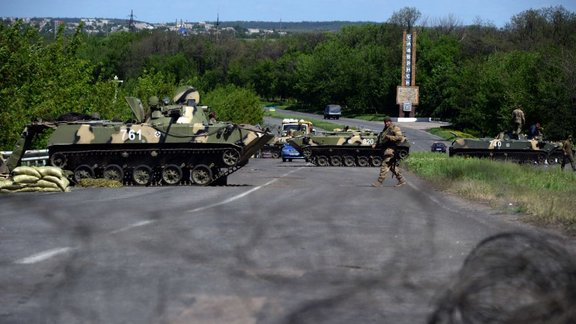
405,152,576,234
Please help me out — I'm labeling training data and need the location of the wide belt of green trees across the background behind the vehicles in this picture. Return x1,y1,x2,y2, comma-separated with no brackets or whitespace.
0,7,576,149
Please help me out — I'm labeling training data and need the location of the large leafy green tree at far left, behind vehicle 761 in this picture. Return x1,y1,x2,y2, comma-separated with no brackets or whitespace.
0,23,112,148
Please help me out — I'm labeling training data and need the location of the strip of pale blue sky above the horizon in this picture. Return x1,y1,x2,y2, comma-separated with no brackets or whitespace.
0,0,576,27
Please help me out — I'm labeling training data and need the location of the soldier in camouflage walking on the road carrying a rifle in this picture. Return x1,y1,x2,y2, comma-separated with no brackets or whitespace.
372,117,406,187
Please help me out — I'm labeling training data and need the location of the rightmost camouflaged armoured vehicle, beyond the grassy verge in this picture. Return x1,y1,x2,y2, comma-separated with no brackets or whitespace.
448,133,561,164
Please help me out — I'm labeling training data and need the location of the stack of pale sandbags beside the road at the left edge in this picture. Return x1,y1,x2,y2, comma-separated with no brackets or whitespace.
0,166,70,192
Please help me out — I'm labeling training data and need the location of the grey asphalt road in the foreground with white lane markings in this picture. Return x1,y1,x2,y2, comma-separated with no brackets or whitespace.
0,159,536,324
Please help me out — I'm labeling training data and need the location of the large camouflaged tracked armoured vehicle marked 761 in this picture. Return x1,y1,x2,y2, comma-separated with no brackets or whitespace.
7,87,273,186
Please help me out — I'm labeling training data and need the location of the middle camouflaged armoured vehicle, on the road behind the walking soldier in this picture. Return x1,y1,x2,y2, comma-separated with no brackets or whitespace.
288,130,410,167
